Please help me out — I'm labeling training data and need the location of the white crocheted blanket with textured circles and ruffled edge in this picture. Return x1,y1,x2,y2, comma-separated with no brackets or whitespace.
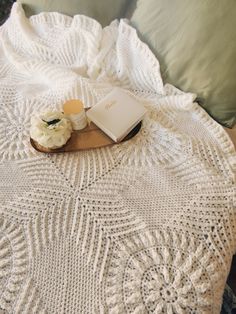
0,4,236,314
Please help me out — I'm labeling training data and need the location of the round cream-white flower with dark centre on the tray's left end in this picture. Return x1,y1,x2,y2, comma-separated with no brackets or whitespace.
30,111,72,149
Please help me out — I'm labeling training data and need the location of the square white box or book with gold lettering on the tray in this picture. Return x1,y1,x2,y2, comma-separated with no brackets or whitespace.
86,87,146,142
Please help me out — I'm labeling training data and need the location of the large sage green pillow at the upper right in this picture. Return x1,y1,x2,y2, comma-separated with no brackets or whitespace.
131,0,236,127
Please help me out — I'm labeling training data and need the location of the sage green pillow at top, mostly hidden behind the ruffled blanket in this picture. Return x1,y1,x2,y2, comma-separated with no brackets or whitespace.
18,0,133,26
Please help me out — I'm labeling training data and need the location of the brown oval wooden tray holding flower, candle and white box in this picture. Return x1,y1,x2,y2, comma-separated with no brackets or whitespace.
30,122,142,153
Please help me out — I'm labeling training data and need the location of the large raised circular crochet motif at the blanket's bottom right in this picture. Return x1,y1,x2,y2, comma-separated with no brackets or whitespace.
107,229,218,314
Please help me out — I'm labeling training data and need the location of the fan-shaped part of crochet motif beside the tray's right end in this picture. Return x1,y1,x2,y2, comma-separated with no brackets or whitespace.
112,108,187,167
